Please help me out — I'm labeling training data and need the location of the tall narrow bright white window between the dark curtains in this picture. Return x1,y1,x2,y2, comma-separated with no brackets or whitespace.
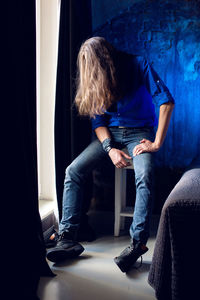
36,0,60,219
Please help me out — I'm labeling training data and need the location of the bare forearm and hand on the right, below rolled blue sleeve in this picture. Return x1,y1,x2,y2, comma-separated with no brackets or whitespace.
133,102,174,156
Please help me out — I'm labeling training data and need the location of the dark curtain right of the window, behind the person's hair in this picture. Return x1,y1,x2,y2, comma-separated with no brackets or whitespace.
55,0,92,218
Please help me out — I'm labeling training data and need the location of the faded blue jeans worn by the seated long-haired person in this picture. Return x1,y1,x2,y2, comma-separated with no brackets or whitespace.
59,127,154,244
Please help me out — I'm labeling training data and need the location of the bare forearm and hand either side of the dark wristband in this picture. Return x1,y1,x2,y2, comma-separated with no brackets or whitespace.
95,126,131,168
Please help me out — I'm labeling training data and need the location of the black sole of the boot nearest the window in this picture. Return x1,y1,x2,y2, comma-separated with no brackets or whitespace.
47,245,84,262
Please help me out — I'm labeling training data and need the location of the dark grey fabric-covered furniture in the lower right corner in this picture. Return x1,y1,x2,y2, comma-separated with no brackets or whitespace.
148,160,200,300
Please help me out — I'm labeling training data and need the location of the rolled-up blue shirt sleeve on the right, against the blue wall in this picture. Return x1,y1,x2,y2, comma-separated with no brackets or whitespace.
141,59,174,106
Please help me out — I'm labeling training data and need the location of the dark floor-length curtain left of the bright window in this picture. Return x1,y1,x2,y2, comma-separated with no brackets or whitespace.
4,0,52,300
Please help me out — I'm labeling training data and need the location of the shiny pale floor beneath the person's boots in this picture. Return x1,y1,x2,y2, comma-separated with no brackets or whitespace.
38,212,159,300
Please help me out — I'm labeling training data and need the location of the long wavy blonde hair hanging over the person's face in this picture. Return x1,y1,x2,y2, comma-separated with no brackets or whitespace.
75,37,119,117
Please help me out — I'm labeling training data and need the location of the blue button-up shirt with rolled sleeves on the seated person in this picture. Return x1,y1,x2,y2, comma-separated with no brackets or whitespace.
91,52,174,130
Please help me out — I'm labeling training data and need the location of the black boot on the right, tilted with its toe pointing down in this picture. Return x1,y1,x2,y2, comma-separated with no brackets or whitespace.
114,241,149,273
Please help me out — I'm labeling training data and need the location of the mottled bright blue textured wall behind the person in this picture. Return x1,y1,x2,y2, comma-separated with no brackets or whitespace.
92,0,200,167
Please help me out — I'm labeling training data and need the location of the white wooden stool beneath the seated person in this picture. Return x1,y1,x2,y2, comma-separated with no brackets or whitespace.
114,149,134,236
